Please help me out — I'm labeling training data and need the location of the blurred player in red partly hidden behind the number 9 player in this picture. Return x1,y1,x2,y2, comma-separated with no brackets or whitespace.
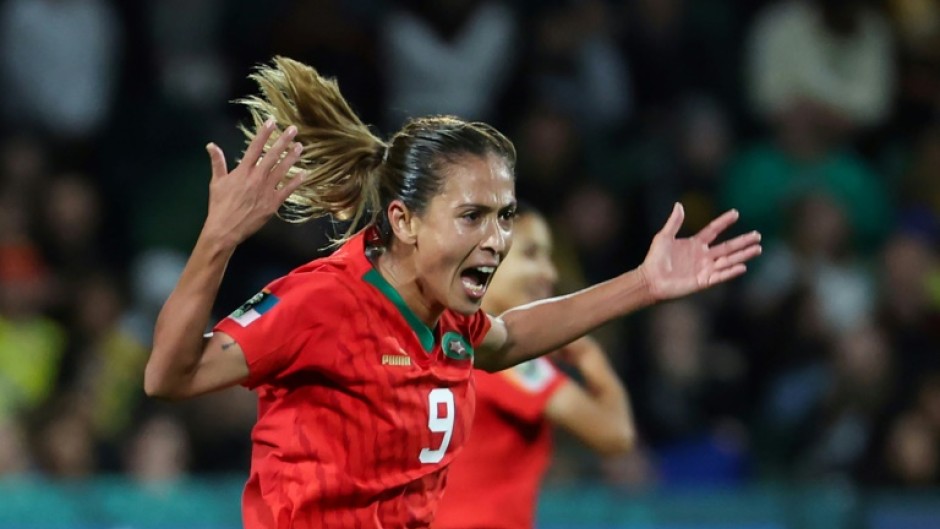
434,203,636,529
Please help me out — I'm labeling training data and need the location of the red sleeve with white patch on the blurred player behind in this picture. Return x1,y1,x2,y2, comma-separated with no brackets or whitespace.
477,358,569,422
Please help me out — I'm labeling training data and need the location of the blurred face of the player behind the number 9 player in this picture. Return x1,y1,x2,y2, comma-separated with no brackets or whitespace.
485,213,558,314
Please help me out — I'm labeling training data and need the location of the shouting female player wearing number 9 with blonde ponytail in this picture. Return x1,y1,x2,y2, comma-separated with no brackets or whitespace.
144,58,760,529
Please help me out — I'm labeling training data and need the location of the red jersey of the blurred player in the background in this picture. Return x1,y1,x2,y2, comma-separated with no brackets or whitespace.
434,358,568,529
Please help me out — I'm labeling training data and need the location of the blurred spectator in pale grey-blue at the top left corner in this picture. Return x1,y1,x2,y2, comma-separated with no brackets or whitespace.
0,0,122,161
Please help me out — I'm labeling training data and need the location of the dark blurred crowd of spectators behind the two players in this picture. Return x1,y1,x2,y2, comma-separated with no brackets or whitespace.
0,0,940,500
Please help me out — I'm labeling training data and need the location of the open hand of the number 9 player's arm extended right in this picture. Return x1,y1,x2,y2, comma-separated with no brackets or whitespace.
640,202,761,301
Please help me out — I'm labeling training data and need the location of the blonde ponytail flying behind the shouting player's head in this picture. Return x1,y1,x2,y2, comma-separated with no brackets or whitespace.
238,57,388,240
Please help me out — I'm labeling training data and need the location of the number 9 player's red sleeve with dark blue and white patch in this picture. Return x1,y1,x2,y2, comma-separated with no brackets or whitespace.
214,273,352,389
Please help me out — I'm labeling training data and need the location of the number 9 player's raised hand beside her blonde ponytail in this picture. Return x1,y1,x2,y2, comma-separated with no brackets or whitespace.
203,120,305,248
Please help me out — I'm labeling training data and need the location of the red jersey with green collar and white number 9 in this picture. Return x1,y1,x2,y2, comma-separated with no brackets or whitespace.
216,233,490,529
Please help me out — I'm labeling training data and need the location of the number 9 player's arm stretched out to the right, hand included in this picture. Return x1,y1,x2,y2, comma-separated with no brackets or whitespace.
477,203,761,371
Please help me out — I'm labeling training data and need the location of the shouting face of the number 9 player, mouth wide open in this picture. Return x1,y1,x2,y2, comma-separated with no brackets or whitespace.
414,156,516,314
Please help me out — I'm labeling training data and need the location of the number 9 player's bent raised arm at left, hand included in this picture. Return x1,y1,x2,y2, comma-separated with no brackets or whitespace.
144,122,302,398
